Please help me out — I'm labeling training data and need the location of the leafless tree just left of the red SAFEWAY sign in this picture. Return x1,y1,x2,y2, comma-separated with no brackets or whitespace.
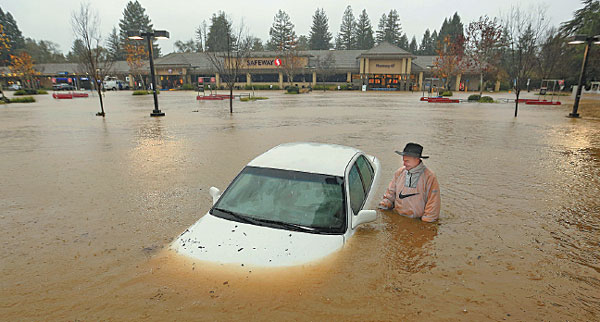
205,21,252,113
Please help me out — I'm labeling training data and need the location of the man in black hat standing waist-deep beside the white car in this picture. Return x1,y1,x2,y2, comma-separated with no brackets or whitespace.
379,143,441,222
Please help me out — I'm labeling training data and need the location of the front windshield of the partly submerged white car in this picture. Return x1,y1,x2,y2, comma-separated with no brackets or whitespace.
211,167,346,234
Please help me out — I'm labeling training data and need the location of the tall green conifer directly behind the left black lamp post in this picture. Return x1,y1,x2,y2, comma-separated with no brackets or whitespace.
119,0,160,57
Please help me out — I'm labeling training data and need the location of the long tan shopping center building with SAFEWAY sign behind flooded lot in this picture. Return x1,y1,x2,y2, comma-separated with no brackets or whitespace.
0,42,490,91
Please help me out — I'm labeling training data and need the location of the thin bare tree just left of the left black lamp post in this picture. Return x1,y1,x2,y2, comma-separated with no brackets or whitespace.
71,3,112,117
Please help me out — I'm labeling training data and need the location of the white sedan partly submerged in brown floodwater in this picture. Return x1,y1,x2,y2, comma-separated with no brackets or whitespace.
171,143,380,266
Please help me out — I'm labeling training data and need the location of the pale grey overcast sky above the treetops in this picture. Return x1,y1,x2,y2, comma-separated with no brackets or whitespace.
0,0,583,54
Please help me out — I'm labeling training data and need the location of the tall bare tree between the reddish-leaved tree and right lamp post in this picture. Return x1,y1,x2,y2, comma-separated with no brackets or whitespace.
502,7,548,117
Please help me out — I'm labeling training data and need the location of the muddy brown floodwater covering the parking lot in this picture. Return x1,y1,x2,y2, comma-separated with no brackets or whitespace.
0,92,600,321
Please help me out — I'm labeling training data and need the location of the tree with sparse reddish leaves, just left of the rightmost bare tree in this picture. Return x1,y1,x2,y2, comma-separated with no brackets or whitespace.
465,16,502,97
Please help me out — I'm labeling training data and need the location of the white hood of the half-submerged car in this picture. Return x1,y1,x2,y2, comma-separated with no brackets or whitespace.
170,213,344,267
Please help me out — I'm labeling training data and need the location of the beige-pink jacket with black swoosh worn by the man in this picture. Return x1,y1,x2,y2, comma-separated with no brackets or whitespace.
379,167,441,222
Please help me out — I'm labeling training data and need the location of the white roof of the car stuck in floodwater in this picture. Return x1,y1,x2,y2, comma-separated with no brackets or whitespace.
248,142,361,177
